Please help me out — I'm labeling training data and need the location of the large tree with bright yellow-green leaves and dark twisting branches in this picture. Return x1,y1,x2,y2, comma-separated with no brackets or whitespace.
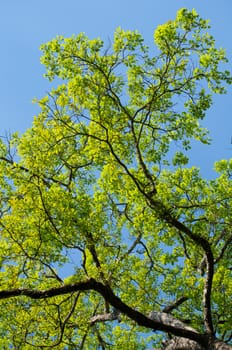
0,9,232,349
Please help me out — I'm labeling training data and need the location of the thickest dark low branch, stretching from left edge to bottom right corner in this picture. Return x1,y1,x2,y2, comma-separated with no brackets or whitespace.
0,278,232,350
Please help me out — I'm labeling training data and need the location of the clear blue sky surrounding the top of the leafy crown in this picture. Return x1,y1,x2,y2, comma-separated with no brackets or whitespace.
0,0,232,177
